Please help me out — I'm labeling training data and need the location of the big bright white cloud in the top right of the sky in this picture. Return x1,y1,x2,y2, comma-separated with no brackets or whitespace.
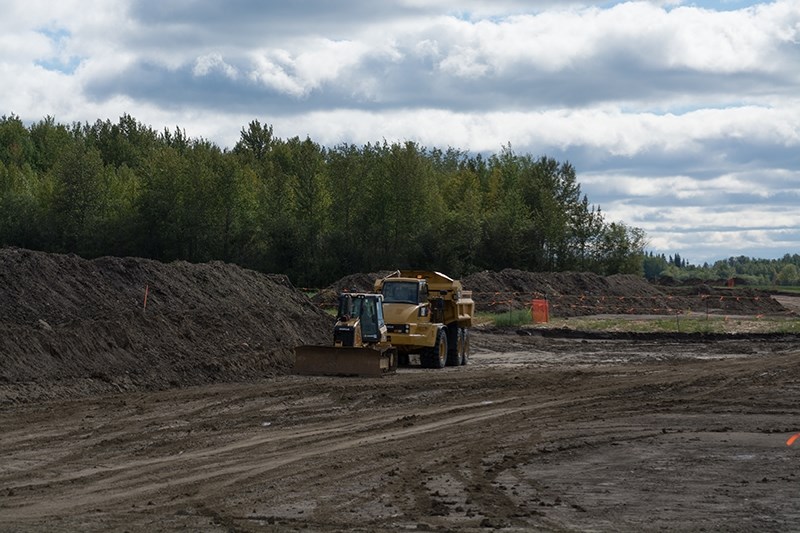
396,2,798,83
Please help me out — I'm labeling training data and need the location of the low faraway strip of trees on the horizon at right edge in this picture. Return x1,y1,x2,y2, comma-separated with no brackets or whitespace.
643,252,800,285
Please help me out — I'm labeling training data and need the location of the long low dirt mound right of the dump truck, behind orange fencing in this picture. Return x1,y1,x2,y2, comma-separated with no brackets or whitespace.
462,269,788,317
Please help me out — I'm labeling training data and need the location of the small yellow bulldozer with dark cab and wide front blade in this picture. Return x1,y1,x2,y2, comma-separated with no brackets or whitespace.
294,293,397,376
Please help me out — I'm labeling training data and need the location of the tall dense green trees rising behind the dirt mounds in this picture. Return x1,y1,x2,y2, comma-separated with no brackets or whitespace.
0,115,644,287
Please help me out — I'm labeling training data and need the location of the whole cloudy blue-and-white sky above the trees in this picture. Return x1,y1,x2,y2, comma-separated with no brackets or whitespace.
0,0,800,264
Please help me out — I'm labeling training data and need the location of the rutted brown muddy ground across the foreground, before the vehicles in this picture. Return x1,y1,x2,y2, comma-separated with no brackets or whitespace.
0,332,800,531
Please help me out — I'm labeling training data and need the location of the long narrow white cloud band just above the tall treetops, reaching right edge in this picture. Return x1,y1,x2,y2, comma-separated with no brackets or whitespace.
268,100,800,156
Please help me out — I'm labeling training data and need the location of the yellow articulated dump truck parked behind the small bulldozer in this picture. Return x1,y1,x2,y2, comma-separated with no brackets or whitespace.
375,270,475,368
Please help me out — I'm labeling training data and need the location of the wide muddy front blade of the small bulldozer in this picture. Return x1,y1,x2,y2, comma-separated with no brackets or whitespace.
294,345,397,376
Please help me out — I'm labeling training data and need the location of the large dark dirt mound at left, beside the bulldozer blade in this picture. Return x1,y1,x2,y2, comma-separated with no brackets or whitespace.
0,248,332,403
